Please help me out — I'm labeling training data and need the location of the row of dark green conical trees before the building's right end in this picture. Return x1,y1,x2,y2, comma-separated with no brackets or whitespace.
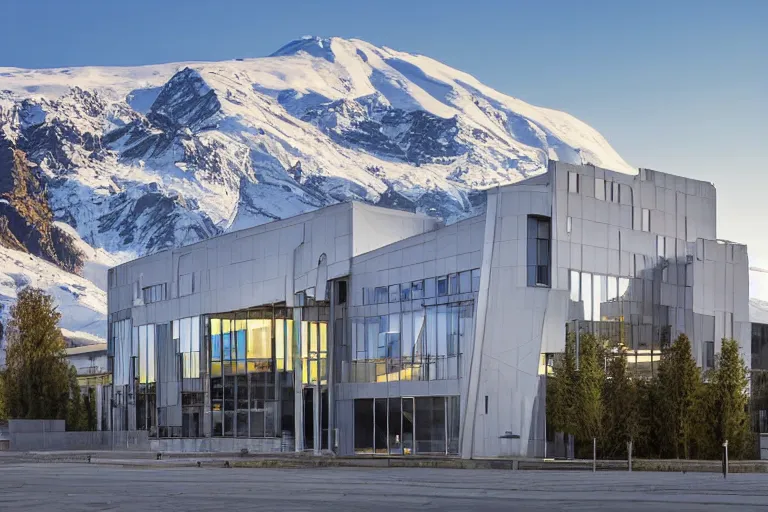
547,333,756,459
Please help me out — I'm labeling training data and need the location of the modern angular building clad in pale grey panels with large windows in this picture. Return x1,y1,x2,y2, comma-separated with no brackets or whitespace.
108,162,751,457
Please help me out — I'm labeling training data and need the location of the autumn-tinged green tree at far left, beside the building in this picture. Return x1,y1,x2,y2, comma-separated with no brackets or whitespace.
0,287,96,430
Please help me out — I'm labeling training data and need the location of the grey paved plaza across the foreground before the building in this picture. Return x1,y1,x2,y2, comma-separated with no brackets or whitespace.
0,463,768,512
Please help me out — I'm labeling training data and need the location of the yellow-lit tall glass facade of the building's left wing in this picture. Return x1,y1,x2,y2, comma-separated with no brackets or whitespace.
108,308,306,438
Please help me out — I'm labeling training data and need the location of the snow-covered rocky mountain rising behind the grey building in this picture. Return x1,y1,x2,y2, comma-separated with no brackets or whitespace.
0,38,635,348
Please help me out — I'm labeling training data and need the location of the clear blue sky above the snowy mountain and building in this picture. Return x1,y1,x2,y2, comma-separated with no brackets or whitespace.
0,0,768,282
